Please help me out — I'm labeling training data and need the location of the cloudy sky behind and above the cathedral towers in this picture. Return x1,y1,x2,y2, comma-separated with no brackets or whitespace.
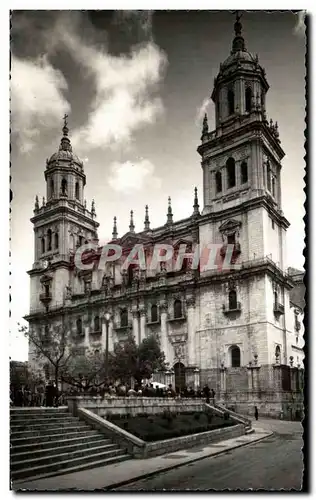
11,11,305,359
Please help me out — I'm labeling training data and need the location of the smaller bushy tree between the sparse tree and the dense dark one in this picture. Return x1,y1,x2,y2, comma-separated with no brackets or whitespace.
61,351,105,391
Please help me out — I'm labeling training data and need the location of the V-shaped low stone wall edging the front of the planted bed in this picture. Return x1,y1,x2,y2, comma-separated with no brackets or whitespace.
78,408,245,458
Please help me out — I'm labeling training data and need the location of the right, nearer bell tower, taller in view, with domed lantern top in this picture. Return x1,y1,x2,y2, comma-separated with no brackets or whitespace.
198,14,289,267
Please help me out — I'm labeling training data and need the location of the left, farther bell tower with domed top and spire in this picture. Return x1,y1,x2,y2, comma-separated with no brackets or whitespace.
29,115,99,312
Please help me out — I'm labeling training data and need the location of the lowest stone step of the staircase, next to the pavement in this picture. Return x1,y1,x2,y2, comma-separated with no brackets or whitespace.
13,453,131,489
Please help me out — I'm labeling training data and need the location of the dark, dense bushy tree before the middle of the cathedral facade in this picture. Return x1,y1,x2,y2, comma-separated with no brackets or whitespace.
109,335,167,384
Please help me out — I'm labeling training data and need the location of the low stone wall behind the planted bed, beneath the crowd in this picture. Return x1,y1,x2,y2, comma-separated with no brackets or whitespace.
67,396,205,417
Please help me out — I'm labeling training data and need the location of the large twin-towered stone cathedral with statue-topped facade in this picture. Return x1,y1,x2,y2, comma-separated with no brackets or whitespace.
26,18,304,412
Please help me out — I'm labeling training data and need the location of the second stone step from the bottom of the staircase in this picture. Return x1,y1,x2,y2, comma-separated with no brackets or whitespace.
11,449,130,480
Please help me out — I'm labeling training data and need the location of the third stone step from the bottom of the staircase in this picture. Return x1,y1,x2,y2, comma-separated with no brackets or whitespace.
11,444,122,473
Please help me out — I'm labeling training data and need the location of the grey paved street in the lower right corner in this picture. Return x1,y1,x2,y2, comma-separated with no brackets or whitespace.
116,420,303,491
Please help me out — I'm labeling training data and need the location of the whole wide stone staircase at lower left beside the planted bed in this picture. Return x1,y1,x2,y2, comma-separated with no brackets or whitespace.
10,407,131,483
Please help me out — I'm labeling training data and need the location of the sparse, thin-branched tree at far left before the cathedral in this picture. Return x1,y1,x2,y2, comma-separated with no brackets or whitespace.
18,322,73,387
